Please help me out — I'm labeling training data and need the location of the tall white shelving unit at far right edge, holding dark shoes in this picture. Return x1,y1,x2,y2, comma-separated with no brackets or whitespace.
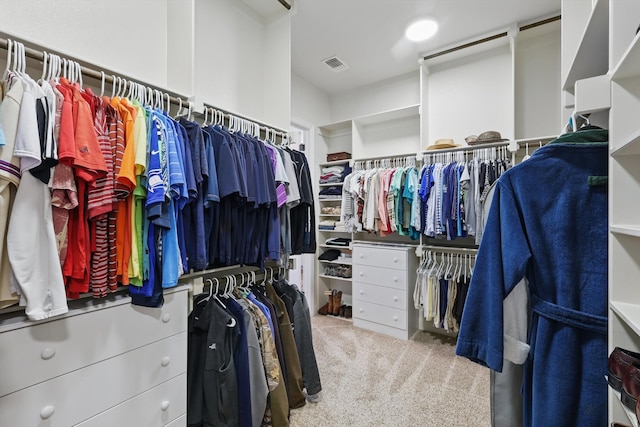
609,0,640,426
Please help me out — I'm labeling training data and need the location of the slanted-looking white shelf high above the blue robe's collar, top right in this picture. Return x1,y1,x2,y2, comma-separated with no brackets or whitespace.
562,0,609,93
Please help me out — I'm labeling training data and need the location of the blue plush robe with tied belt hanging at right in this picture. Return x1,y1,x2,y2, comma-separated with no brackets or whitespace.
456,128,608,427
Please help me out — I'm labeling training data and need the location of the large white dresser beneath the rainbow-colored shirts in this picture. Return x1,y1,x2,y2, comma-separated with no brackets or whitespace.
0,286,190,427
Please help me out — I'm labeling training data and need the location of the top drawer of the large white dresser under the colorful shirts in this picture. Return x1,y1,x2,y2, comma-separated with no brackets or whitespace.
0,288,188,396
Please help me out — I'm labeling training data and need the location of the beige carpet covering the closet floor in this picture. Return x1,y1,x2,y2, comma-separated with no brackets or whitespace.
291,315,491,427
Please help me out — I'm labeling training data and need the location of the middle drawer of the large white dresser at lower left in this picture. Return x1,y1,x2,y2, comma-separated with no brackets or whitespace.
0,332,187,427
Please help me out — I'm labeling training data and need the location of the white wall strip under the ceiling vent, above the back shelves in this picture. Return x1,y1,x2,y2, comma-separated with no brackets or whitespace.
331,71,420,122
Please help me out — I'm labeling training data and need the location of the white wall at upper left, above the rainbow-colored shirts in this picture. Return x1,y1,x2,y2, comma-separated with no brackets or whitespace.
0,0,167,87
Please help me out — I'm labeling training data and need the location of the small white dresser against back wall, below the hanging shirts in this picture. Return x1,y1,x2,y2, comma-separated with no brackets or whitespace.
352,243,418,339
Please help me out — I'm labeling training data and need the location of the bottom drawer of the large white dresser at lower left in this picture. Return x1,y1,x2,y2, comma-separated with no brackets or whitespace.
77,374,187,427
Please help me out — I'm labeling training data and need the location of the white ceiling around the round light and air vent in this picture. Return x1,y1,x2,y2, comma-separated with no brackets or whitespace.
291,0,560,94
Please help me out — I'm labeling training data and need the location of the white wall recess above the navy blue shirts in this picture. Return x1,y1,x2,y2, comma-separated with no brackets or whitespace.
195,0,290,128
